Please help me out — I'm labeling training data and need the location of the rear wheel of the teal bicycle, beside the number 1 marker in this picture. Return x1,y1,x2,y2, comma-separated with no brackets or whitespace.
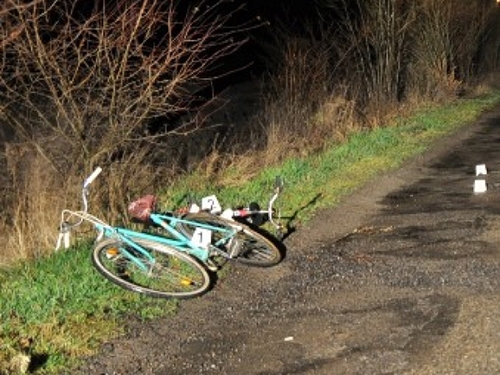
177,212,283,267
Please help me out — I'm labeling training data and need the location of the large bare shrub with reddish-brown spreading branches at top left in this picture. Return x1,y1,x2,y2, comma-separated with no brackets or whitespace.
0,0,248,172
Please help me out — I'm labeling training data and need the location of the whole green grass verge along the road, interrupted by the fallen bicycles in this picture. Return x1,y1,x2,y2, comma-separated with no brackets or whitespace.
0,92,500,374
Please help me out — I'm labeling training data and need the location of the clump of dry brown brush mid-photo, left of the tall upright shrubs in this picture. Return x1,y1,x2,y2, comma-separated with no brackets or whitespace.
258,32,359,160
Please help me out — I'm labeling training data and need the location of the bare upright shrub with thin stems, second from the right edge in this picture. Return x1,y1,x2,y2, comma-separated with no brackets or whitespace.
323,0,415,107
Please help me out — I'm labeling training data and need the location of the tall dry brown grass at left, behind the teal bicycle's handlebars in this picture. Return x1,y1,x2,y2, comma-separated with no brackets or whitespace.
0,145,175,264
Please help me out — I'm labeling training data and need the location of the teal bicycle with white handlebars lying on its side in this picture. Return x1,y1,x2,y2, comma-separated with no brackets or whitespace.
56,168,281,299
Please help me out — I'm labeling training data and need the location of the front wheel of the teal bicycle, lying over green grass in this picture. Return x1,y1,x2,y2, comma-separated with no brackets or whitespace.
92,238,211,299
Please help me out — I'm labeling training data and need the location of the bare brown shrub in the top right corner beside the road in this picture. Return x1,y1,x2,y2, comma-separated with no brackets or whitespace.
411,0,497,98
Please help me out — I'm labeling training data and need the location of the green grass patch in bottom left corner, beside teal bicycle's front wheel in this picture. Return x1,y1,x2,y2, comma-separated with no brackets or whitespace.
0,244,177,373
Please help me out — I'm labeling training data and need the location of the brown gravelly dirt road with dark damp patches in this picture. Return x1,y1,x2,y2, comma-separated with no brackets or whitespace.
73,108,500,375
